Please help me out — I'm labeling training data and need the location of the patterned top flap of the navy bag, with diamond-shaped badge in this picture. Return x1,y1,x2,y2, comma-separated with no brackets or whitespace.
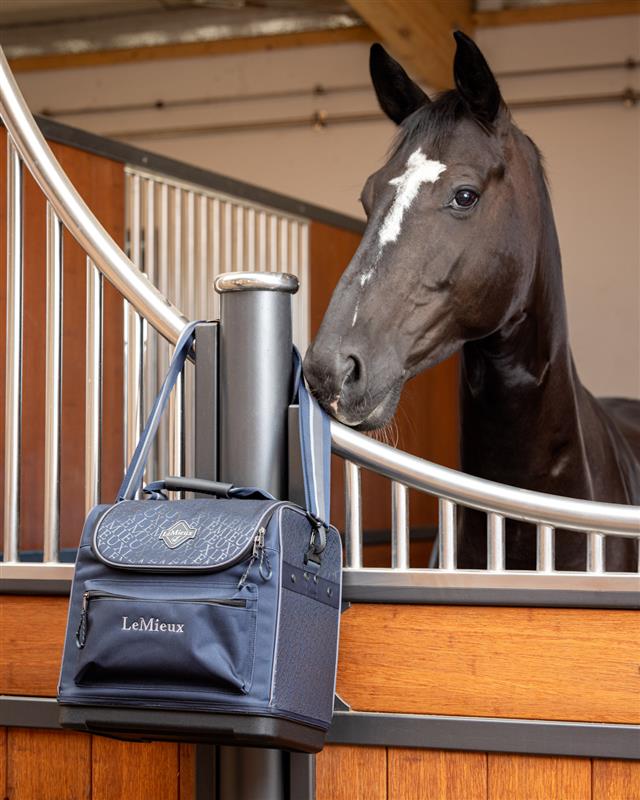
93,499,279,572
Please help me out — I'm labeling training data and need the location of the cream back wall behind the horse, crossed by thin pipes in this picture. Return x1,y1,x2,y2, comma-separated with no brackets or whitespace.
19,16,640,397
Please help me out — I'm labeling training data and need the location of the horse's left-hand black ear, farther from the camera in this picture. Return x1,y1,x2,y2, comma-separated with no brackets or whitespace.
369,43,430,125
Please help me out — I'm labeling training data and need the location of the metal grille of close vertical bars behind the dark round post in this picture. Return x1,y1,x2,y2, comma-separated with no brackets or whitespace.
125,167,309,479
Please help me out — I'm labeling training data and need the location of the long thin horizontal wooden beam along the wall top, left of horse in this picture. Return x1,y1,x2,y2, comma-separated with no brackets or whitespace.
9,25,374,72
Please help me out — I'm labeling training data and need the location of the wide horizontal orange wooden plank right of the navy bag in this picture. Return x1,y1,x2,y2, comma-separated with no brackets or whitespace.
337,604,640,723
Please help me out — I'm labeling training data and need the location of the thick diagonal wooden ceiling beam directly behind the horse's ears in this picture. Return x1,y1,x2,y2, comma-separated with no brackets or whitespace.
349,0,473,89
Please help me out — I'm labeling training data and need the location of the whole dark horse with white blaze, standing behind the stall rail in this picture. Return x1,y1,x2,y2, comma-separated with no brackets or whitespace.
304,33,640,571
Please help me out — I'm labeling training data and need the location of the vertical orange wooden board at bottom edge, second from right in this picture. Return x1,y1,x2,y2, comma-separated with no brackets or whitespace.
487,753,592,800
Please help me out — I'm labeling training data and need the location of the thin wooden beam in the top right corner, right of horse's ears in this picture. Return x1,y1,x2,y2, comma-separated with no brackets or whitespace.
473,0,640,28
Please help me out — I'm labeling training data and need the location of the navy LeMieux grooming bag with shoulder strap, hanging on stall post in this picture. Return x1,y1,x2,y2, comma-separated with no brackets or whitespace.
58,324,342,752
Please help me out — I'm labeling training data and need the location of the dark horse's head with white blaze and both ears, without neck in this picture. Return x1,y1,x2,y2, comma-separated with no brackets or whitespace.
304,32,544,430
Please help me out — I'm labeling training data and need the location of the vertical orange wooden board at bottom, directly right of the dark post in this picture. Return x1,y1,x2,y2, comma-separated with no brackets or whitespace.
316,745,387,800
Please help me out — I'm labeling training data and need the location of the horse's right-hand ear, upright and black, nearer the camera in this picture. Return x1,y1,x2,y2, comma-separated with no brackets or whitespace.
453,31,502,123
